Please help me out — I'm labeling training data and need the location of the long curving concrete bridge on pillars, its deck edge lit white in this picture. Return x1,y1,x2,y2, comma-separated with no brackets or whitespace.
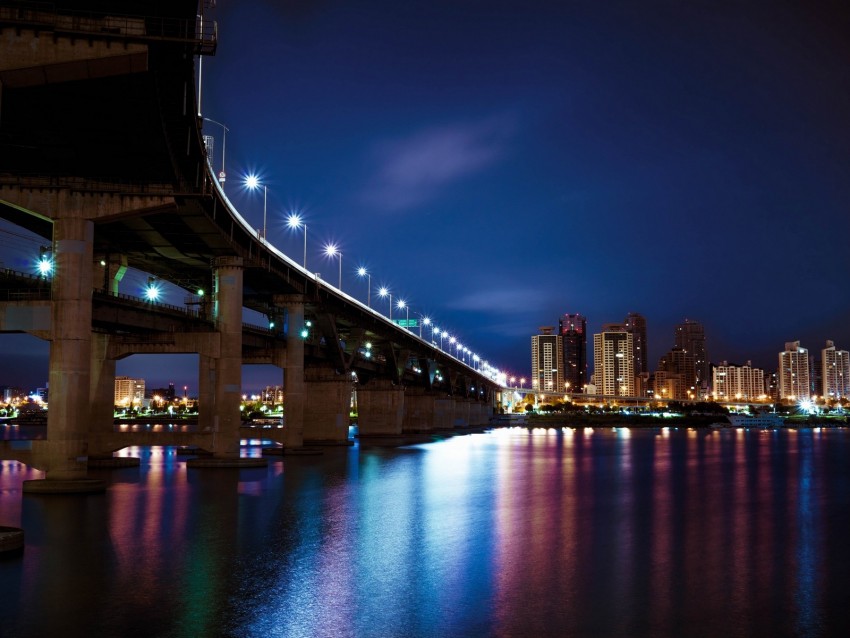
0,0,501,491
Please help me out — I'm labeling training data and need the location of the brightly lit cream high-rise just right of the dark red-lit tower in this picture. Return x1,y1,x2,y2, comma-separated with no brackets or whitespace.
593,324,635,397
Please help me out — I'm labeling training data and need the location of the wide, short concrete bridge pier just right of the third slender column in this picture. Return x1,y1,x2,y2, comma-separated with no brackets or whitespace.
304,366,351,445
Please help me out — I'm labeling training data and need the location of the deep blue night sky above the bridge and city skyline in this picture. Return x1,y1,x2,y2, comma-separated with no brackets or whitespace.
0,0,850,396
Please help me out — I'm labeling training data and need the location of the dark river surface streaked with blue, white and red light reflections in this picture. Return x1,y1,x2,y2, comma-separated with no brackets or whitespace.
0,428,850,638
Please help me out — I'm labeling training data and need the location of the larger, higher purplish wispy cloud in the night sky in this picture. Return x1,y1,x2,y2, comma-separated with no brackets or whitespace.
364,117,514,211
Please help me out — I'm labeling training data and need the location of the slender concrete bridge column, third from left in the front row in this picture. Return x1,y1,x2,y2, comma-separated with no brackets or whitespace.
274,295,304,448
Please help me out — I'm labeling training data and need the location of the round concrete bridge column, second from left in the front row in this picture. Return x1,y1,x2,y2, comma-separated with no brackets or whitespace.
212,257,242,458
